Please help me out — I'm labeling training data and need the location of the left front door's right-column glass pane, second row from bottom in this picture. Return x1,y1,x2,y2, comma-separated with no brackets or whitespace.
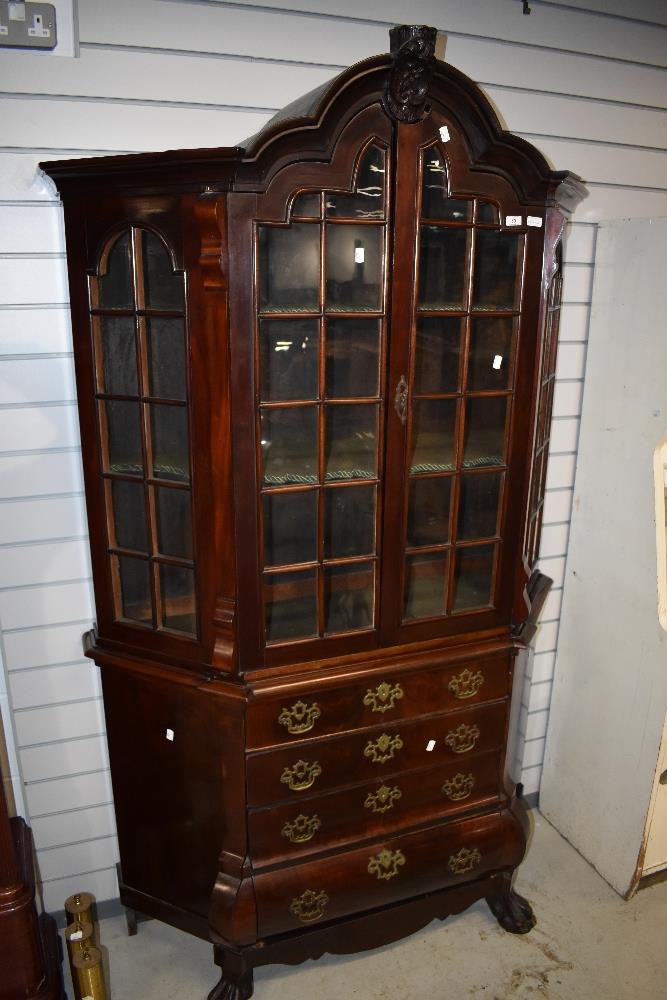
324,486,375,559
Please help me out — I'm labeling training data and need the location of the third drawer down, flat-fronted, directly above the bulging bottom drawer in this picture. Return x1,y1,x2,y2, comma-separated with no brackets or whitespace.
248,750,501,868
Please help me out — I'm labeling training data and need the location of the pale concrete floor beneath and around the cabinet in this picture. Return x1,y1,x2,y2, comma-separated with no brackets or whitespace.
65,812,667,1000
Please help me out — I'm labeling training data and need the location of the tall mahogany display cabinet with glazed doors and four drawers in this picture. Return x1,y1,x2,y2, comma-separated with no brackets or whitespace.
43,26,583,998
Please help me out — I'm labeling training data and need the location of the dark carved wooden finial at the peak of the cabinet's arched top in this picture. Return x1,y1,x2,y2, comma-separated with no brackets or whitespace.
384,24,437,122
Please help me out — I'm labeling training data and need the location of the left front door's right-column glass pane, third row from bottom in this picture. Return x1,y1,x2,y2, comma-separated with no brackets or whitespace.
324,405,378,480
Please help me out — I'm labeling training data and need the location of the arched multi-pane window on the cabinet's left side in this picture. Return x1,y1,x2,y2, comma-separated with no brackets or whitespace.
90,226,197,636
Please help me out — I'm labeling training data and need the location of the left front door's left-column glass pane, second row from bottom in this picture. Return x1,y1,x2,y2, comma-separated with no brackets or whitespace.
264,490,317,566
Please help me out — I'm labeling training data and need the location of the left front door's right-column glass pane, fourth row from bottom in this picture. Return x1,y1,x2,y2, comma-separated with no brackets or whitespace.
326,319,381,399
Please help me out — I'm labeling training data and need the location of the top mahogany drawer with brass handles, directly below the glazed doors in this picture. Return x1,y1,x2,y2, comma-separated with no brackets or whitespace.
247,652,511,749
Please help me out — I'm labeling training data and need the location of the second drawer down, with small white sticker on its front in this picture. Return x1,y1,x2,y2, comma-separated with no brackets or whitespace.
246,701,507,805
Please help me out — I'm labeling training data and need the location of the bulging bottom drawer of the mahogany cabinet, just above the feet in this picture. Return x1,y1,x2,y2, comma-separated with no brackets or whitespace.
255,812,524,937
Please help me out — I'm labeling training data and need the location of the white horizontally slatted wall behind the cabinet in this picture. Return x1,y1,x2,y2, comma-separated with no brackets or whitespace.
0,0,667,910
